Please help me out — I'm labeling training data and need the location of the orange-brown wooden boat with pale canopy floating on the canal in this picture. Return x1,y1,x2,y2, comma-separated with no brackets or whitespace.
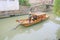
16,13,48,26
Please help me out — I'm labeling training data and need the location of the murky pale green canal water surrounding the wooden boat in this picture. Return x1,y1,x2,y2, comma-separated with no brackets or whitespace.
0,13,60,40
